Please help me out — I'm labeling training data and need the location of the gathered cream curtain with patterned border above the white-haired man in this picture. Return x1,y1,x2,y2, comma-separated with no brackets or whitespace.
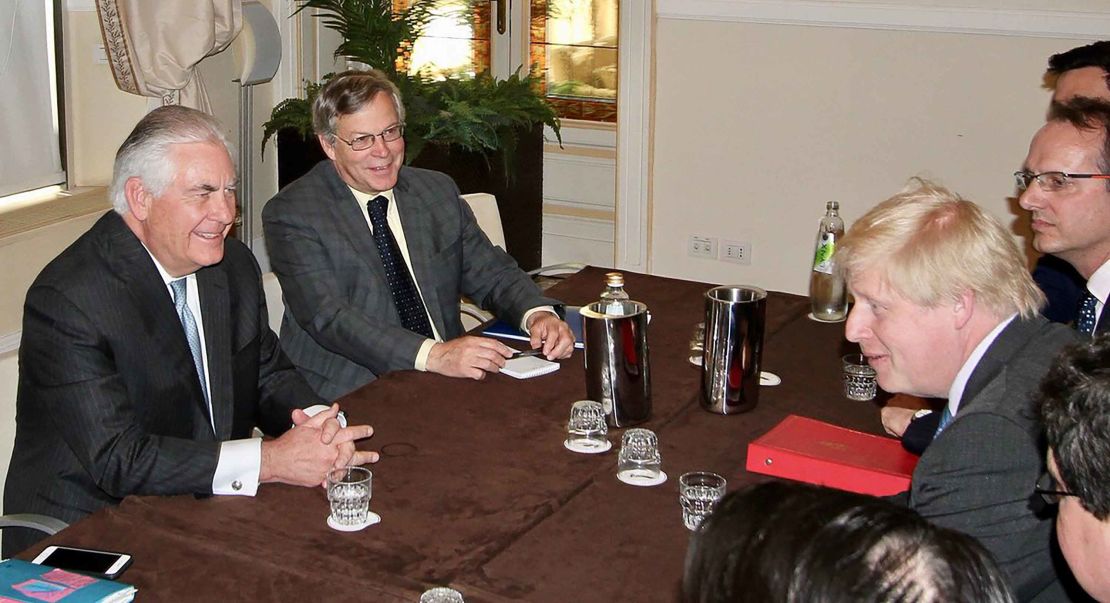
97,0,243,113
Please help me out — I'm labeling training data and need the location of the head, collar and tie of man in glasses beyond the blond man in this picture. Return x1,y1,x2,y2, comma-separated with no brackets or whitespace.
1015,97,1110,334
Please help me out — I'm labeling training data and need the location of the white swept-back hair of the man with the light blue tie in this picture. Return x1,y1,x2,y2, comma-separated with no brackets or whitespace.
108,104,235,215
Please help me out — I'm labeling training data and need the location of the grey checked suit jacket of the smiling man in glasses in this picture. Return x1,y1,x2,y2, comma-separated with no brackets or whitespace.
262,161,558,399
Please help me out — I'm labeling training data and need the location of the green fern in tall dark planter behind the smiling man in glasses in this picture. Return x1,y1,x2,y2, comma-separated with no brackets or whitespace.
262,0,562,270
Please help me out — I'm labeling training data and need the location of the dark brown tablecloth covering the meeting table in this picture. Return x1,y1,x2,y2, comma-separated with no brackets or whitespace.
21,269,880,603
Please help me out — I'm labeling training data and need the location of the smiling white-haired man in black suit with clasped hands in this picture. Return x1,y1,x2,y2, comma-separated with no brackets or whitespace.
3,107,377,555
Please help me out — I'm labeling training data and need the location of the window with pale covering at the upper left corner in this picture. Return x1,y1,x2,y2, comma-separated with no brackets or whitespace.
0,0,65,198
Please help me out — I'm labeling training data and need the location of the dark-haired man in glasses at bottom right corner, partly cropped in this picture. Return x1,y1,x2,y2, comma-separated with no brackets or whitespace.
1036,336,1110,601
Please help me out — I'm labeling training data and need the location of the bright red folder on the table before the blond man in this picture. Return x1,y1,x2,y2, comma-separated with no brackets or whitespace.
747,414,918,496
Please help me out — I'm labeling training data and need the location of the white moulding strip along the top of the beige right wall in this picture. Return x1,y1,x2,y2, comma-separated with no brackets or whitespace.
657,0,1110,40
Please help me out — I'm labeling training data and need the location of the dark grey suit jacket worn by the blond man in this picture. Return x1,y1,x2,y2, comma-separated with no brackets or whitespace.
888,316,1078,601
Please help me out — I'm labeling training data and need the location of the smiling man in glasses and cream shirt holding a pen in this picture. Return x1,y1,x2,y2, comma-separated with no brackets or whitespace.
262,71,574,398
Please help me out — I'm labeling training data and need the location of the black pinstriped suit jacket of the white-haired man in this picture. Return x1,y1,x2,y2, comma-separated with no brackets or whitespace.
3,212,319,555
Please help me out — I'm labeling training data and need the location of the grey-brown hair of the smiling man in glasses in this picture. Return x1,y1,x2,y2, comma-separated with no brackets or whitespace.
312,69,405,144
